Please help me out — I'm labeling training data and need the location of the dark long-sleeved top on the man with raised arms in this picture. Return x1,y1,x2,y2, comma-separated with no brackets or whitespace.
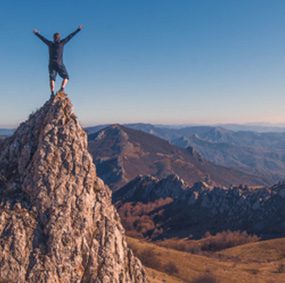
35,28,80,65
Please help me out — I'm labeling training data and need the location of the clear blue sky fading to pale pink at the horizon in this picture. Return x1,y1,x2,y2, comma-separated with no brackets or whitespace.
0,0,285,127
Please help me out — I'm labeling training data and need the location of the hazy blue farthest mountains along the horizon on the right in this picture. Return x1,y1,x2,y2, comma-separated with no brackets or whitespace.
122,124,285,184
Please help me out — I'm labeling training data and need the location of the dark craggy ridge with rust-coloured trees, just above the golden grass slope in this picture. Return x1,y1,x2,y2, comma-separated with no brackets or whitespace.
113,175,285,239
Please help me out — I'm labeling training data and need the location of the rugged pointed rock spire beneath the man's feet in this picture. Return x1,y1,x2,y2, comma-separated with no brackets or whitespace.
0,94,147,283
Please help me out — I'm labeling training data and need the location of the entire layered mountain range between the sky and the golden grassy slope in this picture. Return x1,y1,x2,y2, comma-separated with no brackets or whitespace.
88,124,285,240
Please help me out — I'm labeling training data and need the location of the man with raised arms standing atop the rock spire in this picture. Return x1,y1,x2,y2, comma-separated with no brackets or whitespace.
33,25,83,95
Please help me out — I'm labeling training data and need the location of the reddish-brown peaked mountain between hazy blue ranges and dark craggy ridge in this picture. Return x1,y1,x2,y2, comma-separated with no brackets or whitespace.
88,125,266,190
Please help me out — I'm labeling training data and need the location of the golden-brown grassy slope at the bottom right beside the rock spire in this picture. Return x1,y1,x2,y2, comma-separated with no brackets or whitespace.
128,238,285,283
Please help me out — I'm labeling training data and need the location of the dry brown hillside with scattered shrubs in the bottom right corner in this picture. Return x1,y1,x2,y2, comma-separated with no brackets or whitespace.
128,238,285,283
